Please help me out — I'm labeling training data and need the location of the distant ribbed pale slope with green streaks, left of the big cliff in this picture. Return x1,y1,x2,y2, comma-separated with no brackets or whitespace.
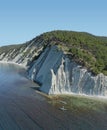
0,39,43,66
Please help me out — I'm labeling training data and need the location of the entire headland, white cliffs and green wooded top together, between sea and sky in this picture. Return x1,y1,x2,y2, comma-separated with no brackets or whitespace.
0,31,107,95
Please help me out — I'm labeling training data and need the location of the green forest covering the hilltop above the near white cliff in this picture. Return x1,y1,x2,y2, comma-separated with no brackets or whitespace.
40,31,107,75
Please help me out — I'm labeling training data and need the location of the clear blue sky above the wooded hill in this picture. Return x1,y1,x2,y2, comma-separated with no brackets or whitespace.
0,0,107,46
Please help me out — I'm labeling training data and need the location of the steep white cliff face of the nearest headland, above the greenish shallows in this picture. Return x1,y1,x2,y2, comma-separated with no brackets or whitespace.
29,46,107,95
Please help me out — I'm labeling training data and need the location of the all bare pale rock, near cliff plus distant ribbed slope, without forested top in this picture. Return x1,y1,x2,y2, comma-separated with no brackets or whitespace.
0,31,107,96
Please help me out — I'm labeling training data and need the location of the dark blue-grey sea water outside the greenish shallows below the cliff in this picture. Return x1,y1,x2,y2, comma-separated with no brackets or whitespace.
0,62,107,130
